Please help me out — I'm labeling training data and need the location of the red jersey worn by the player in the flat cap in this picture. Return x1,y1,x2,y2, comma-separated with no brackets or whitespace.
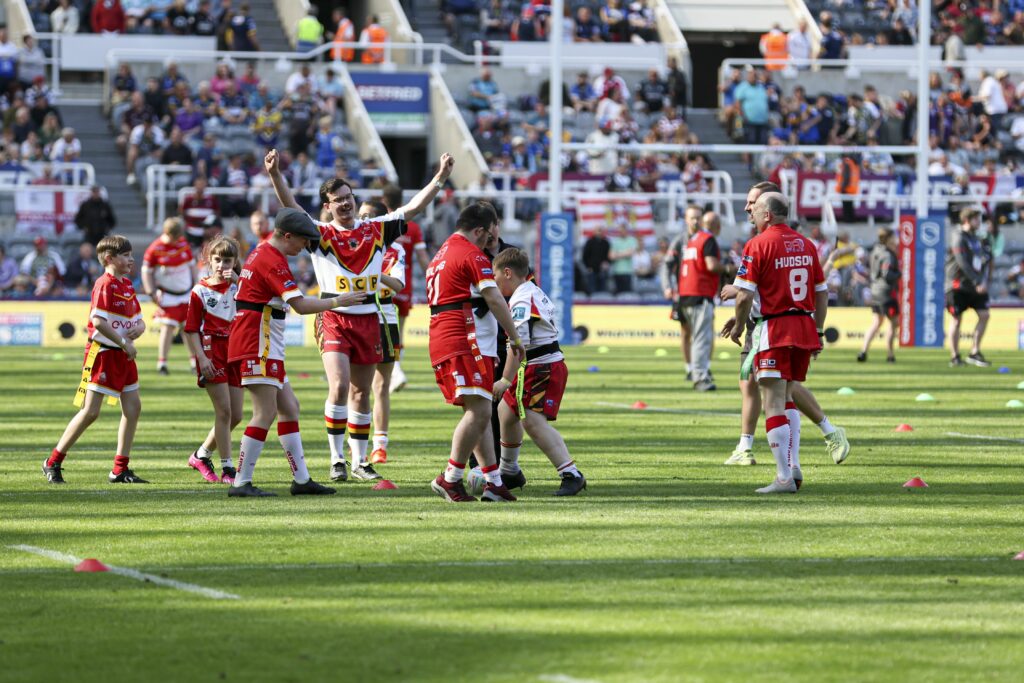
227,242,302,362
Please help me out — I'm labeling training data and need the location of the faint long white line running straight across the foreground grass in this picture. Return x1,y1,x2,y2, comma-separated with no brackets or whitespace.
123,556,1008,573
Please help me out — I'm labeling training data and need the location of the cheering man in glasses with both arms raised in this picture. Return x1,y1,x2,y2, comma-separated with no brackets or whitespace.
264,150,454,481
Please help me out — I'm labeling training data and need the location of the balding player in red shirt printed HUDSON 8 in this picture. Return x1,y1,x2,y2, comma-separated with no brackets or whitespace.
728,193,828,494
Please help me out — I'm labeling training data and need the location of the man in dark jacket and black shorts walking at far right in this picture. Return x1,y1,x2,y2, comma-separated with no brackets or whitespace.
946,208,992,368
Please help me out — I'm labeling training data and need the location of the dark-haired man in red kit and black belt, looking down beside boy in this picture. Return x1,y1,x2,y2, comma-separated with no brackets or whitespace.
427,202,524,503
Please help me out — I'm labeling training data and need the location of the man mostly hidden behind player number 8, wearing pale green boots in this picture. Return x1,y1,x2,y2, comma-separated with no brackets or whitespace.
721,181,850,465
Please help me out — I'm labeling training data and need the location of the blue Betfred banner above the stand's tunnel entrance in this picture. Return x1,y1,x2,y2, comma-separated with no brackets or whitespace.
352,72,430,133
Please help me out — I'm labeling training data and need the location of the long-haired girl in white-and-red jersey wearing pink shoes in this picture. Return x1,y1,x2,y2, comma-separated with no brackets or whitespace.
185,237,245,484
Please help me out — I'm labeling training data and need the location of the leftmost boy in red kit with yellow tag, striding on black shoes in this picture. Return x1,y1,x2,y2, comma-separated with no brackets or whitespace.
43,234,148,483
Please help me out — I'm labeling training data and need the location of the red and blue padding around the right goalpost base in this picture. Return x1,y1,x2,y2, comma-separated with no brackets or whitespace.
899,211,946,348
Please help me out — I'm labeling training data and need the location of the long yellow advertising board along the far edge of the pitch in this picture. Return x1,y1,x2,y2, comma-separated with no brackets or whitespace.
0,301,1024,350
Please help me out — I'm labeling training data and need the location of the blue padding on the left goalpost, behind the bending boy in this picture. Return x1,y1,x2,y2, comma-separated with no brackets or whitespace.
537,213,574,346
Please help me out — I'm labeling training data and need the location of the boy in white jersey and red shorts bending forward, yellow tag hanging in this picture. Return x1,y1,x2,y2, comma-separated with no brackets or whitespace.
494,249,587,496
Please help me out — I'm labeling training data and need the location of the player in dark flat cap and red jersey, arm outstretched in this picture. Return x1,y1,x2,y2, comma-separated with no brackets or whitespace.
227,208,365,498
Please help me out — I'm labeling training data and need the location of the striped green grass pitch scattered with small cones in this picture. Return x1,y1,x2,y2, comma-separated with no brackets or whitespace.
0,344,1024,683
